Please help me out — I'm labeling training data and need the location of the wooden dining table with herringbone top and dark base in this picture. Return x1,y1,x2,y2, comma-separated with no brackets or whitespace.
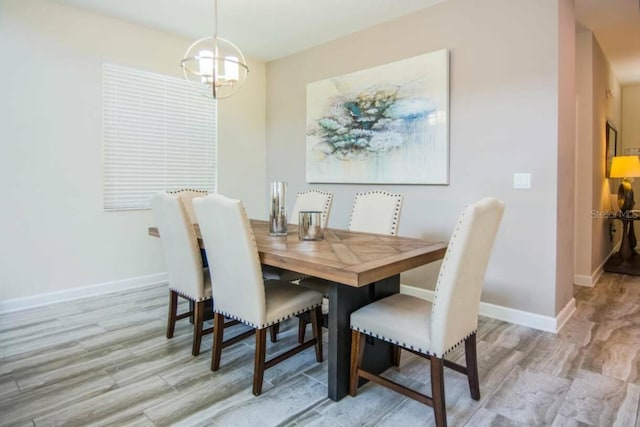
148,219,447,401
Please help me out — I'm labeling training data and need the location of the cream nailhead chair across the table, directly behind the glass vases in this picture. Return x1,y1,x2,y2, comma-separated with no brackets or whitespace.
262,188,333,284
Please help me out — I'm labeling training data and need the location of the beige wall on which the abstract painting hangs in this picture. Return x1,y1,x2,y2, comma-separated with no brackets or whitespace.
267,0,575,316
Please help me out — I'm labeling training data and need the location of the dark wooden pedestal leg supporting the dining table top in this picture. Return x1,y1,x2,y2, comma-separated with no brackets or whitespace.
327,275,400,401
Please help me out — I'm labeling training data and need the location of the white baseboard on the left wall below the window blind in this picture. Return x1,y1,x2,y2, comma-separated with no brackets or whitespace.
0,273,169,314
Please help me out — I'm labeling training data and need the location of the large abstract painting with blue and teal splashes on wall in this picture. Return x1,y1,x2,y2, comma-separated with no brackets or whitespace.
306,49,449,184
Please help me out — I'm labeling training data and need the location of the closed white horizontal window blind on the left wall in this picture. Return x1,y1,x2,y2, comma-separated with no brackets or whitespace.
102,64,217,210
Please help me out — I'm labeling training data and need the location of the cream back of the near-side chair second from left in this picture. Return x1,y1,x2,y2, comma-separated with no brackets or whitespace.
193,194,266,327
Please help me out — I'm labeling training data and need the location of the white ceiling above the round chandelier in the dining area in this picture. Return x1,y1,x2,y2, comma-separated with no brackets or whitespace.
51,0,446,61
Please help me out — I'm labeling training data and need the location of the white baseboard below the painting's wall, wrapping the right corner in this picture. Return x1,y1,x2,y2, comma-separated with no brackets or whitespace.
400,285,576,333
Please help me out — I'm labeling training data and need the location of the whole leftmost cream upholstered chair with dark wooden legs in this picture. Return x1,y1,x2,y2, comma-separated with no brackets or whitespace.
151,193,212,356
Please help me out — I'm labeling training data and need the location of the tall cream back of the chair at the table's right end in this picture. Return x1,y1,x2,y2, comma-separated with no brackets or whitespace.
431,197,504,357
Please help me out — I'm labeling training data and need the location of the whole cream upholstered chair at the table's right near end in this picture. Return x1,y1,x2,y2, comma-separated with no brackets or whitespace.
349,198,504,426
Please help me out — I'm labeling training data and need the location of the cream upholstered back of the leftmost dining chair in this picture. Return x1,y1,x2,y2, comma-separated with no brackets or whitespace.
151,193,205,301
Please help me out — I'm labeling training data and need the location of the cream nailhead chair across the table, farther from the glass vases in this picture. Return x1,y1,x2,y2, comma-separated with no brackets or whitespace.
298,190,402,342
